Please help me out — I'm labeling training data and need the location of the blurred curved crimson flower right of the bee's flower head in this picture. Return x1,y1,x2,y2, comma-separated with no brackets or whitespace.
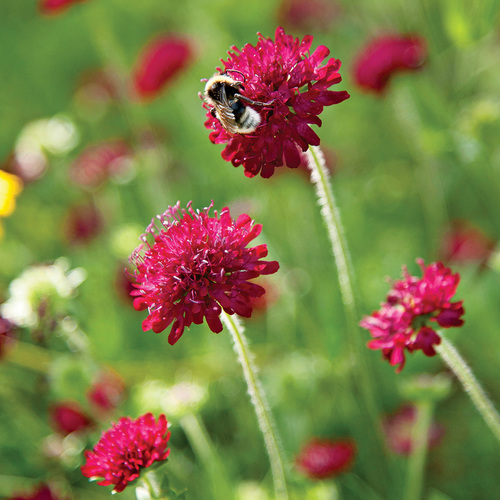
353,35,427,94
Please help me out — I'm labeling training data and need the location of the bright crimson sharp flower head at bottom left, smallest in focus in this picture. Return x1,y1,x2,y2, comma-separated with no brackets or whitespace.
81,413,170,493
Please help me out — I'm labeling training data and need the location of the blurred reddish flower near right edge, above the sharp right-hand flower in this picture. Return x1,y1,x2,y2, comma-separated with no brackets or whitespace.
440,220,496,267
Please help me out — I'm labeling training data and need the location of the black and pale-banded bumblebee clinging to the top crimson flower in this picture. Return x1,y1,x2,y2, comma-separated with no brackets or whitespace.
203,69,274,134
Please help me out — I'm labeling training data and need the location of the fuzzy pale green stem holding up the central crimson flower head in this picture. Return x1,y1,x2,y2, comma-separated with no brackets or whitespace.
221,312,288,500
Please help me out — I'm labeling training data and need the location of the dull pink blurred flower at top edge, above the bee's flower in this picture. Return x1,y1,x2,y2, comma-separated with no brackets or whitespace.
278,0,341,32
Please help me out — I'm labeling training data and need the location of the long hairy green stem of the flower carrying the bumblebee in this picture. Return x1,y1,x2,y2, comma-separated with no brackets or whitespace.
306,146,385,465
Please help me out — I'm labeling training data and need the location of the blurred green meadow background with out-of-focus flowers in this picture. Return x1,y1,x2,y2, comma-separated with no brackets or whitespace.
0,0,500,500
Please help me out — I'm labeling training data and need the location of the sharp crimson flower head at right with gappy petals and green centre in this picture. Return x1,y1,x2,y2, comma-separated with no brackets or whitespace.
360,259,465,373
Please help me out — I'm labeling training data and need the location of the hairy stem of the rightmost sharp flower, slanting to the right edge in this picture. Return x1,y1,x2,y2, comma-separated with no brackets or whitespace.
435,332,500,441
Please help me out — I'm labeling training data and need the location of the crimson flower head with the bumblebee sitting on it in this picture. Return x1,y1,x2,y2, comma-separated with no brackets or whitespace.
204,28,349,178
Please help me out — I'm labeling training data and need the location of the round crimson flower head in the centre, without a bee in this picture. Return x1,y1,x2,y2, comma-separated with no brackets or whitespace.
131,203,279,345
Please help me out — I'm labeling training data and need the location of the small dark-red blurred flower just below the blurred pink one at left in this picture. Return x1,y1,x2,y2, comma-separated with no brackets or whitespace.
63,203,104,245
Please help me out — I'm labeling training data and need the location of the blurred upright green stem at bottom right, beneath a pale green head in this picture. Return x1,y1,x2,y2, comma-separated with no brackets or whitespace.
404,401,434,500
